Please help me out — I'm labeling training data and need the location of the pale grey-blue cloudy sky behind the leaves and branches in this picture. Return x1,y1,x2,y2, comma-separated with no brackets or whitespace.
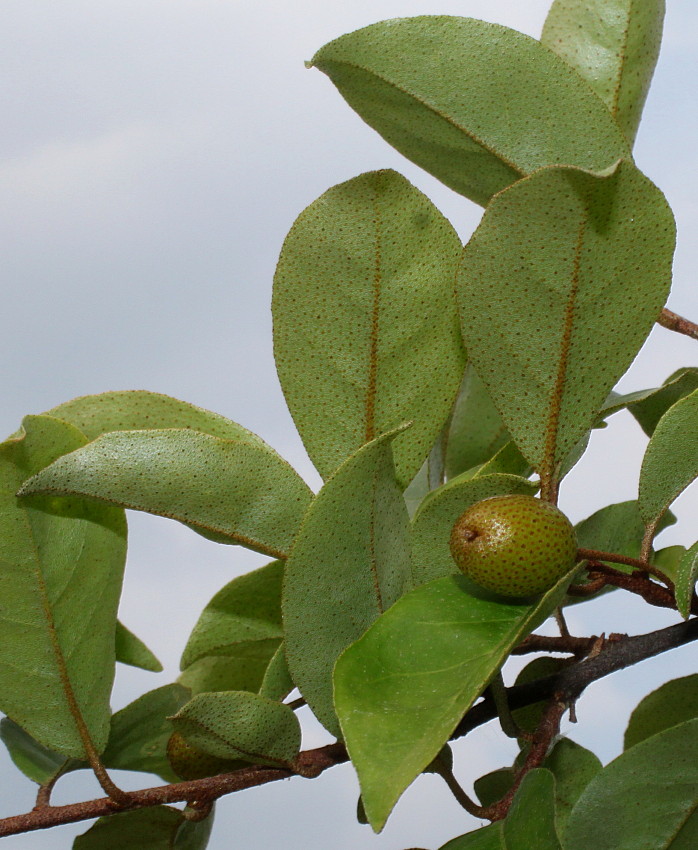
0,0,698,850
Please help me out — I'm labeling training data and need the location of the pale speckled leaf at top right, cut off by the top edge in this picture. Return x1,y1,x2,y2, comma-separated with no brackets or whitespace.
541,0,664,142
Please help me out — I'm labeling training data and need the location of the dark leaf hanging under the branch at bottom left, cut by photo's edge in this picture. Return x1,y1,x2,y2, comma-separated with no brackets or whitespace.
73,806,213,850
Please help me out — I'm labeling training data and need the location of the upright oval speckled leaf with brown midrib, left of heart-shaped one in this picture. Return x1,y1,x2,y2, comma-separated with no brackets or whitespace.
272,171,465,486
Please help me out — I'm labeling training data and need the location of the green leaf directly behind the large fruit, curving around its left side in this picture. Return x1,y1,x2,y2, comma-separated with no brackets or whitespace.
412,475,537,592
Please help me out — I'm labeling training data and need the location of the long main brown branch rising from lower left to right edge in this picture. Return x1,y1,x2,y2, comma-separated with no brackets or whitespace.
0,616,698,837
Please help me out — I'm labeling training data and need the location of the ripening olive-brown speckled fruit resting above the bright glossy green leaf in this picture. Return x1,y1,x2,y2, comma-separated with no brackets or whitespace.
449,495,577,596
